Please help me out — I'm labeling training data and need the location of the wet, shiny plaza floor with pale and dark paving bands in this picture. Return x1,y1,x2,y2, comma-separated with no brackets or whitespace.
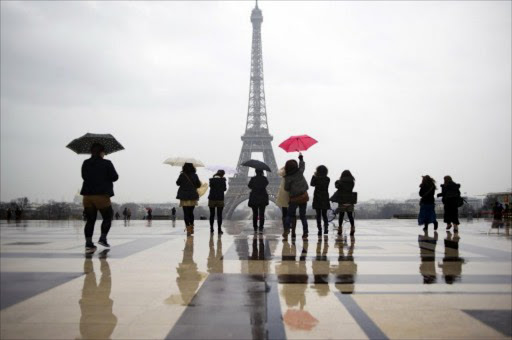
0,220,512,339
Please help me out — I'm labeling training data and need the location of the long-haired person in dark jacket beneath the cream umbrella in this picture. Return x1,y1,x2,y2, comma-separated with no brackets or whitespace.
176,163,201,236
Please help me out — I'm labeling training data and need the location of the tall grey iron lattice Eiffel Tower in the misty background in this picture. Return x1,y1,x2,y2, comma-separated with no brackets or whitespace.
225,1,280,219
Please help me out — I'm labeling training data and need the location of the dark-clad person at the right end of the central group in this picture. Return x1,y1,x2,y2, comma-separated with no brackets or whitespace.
334,170,356,235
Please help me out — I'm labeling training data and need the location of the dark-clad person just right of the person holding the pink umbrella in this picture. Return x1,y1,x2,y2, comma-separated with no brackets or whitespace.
310,165,331,236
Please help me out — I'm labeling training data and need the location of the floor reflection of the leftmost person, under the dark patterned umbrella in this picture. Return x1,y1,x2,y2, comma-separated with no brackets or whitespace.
79,249,117,339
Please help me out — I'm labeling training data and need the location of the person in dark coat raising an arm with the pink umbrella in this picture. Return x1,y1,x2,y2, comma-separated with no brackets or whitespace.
283,154,309,240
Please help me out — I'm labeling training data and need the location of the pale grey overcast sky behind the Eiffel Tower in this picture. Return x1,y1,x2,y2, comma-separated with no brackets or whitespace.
0,1,512,202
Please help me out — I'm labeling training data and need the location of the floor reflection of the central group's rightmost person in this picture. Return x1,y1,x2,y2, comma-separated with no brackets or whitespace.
334,235,357,294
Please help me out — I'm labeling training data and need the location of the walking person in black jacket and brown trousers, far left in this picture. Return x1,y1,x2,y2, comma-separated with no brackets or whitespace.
80,143,119,252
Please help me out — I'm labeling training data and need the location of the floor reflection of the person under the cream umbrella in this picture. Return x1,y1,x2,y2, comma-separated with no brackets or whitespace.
176,236,201,305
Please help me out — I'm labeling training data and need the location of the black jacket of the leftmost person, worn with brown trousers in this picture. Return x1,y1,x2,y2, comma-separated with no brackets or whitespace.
80,157,119,197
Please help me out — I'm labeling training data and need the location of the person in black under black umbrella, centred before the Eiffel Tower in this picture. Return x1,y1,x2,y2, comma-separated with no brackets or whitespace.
248,169,268,234
